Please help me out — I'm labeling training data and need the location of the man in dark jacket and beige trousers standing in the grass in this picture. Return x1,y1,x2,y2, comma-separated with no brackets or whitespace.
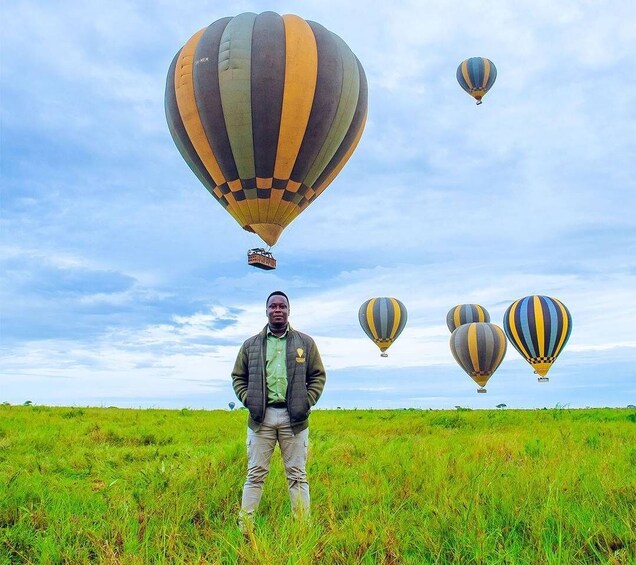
232,290,327,519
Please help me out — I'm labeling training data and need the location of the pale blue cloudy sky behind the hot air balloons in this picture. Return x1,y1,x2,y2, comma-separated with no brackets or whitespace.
0,0,636,408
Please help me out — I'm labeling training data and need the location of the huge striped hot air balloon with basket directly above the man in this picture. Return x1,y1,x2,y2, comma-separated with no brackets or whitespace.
165,12,367,268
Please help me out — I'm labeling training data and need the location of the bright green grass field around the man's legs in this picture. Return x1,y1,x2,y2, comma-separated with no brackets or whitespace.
0,406,636,565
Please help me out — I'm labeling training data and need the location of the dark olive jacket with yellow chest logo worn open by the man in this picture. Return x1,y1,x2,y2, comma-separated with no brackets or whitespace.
232,326,327,434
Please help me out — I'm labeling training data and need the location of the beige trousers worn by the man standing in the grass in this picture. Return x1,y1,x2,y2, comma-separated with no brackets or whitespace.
241,407,309,516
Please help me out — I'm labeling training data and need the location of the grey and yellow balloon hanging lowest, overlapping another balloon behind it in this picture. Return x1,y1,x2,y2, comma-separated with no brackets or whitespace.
450,322,506,392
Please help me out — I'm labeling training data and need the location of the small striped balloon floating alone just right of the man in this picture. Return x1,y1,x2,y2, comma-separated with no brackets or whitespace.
358,297,407,357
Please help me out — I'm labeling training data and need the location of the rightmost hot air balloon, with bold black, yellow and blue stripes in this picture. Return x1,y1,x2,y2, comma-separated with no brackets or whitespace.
504,295,572,382
